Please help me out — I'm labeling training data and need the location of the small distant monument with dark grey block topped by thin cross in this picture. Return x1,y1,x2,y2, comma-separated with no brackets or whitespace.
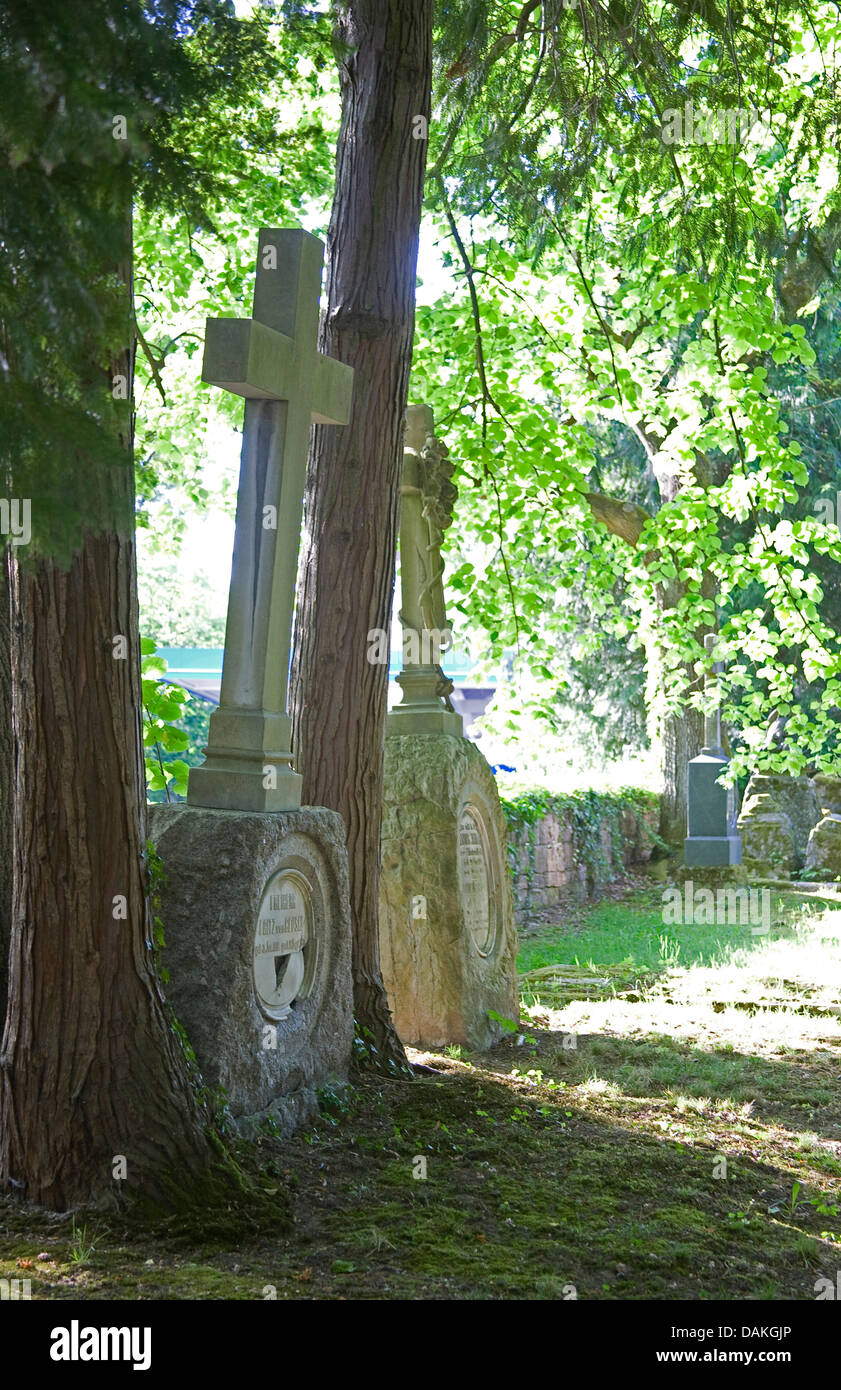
684,632,742,869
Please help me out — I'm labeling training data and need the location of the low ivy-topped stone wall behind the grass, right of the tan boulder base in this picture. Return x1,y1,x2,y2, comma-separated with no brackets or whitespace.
502,792,659,922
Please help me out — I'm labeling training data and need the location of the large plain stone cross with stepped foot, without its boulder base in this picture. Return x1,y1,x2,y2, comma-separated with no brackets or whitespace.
188,228,353,810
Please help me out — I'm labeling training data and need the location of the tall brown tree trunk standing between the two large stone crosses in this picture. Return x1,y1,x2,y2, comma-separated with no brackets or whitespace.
292,0,432,1066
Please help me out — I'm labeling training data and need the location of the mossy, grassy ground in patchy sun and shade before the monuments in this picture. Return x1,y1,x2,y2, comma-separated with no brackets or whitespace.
0,888,841,1300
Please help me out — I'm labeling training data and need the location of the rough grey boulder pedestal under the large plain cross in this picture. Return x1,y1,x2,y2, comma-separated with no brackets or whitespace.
149,803,353,1136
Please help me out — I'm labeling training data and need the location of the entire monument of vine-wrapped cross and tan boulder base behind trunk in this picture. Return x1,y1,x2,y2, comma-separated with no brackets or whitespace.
379,406,519,1048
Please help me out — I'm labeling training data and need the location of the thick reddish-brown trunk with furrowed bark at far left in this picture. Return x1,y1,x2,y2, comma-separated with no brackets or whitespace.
0,216,211,1211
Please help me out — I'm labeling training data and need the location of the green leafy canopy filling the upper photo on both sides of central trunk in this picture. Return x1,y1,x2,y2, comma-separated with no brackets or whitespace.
6,0,841,767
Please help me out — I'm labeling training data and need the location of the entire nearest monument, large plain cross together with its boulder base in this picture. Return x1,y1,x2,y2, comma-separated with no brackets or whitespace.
150,229,353,1133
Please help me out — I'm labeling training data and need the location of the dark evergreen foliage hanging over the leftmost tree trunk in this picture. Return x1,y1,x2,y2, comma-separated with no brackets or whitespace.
0,0,284,555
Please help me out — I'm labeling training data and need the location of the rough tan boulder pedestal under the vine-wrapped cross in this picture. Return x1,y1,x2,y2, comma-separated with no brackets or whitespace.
379,734,519,1048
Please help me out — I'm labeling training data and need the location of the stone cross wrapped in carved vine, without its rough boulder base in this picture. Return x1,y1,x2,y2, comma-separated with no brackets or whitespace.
386,406,463,735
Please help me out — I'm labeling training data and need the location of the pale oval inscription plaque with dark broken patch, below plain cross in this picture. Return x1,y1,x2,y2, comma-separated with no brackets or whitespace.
254,869,313,1020
